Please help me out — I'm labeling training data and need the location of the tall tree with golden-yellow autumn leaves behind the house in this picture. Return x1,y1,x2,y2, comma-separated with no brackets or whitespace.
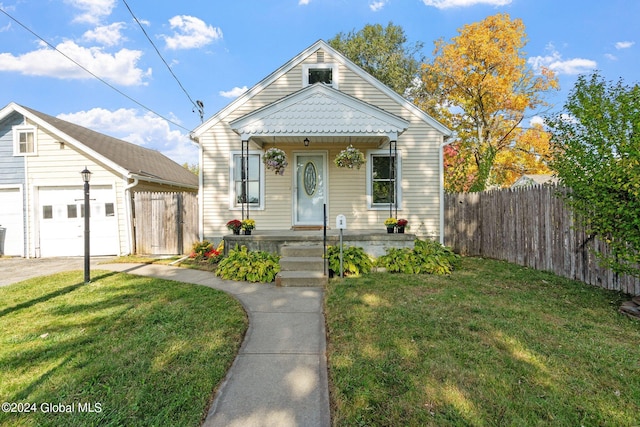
415,14,558,191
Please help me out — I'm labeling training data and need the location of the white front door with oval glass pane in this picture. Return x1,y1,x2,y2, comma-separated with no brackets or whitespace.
293,153,327,225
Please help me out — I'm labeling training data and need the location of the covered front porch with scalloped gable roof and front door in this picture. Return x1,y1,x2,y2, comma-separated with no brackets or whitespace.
229,83,409,232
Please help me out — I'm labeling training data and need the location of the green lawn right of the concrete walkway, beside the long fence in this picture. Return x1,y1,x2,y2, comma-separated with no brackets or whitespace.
326,258,640,427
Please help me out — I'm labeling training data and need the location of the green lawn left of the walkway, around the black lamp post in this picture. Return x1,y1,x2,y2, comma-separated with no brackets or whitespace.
0,271,247,426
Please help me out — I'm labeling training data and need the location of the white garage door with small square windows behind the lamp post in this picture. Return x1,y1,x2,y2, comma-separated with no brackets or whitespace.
38,186,119,257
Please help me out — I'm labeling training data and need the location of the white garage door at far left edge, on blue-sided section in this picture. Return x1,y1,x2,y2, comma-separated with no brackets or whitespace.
0,188,24,256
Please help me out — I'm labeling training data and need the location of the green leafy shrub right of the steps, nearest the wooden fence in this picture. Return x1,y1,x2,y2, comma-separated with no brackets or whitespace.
378,239,460,274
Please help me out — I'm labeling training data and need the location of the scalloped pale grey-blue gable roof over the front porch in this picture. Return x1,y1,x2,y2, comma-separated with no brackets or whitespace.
229,83,409,144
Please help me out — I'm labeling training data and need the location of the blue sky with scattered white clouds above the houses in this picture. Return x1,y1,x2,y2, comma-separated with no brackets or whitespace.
0,0,640,163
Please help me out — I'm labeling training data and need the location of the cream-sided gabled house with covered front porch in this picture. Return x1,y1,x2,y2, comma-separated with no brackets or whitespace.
192,40,451,244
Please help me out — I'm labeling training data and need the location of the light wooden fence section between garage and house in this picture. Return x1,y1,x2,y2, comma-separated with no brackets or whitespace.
133,192,198,255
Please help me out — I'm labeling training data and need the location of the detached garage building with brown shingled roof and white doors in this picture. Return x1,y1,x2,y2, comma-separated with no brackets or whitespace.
0,103,198,257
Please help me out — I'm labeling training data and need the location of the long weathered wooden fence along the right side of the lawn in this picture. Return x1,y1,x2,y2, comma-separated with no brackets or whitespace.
445,186,640,295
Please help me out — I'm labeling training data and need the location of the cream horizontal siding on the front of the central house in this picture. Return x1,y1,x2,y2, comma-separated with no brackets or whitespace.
200,45,443,238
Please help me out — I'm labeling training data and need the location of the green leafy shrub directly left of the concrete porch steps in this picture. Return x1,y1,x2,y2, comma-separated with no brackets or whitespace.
216,245,280,283
